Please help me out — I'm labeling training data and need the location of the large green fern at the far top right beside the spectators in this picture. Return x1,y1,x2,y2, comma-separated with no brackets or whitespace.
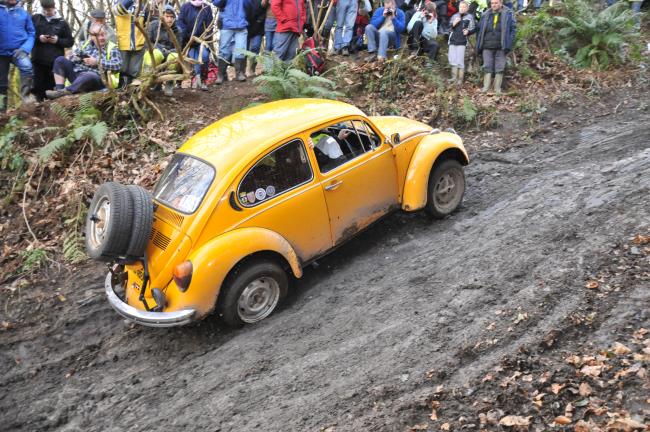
552,0,638,69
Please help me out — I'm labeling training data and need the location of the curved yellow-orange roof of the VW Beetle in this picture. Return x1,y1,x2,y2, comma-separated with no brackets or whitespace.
178,99,364,178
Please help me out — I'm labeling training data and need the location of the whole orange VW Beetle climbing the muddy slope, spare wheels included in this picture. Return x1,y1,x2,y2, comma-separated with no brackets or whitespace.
86,99,468,327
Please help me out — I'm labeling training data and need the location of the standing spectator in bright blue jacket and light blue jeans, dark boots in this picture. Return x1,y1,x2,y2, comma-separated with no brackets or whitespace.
212,0,253,84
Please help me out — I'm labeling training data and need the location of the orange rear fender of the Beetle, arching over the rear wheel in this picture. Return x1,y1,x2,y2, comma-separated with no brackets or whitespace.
185,228,302,316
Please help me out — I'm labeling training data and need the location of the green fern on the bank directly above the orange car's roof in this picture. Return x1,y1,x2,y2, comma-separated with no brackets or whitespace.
253,53,343,100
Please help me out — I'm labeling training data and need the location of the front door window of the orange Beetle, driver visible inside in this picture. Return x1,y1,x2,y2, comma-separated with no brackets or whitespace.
310,121,372,173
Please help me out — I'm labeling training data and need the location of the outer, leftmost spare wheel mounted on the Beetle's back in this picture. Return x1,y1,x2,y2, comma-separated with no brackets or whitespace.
86,182,133,261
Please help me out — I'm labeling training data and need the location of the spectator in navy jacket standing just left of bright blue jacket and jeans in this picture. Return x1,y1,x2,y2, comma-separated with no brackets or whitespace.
177,0,213,90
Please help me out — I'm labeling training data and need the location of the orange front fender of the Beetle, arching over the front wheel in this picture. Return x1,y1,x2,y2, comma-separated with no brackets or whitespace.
402,132,469,211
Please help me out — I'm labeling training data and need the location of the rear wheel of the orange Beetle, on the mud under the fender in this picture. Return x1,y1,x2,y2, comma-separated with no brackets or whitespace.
218,260,289,327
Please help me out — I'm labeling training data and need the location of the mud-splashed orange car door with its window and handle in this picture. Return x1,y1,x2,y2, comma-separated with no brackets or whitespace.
310,118,398,245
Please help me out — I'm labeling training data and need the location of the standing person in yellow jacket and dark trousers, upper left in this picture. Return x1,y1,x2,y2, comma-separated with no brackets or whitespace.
113,0,146,86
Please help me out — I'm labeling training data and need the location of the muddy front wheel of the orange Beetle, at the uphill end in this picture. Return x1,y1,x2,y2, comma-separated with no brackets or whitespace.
425,159,465,219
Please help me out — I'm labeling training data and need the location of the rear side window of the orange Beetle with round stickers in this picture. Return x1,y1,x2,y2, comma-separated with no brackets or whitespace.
237,140,313,207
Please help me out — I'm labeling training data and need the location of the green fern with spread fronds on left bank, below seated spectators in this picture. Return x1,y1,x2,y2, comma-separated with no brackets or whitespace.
38,94,108,162
